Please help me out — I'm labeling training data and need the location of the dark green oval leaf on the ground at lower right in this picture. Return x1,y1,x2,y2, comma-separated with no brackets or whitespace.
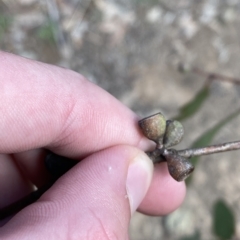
213,199,235,240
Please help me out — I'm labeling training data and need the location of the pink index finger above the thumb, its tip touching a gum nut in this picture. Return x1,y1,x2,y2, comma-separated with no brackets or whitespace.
0,52,150,158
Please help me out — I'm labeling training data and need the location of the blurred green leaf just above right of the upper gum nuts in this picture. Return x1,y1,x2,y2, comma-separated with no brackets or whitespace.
174,85,209,121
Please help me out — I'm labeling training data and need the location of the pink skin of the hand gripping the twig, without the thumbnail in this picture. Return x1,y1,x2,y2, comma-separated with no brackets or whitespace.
0,52,185,239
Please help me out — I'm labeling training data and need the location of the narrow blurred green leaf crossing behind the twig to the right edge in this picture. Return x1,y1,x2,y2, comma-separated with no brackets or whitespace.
186,109,240,184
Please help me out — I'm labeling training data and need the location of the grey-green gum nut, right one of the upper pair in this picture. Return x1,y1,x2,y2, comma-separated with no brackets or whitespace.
163,120,184,148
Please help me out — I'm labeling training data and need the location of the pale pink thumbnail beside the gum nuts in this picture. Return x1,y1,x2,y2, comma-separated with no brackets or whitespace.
126,152,153,214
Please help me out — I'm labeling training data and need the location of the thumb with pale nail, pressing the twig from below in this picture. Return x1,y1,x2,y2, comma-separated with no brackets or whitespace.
0,146,153,239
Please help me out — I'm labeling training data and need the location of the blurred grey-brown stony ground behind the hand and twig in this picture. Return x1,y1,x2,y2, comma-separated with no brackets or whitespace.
0,0,240,240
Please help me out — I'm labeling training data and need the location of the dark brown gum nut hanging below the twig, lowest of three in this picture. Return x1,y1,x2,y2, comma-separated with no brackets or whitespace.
164,149,194,182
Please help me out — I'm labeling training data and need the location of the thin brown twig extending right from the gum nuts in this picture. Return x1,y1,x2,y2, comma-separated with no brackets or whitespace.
177,141,240,158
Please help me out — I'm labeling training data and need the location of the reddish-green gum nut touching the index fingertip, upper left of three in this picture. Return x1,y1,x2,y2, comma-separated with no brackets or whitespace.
138,113,166,144
